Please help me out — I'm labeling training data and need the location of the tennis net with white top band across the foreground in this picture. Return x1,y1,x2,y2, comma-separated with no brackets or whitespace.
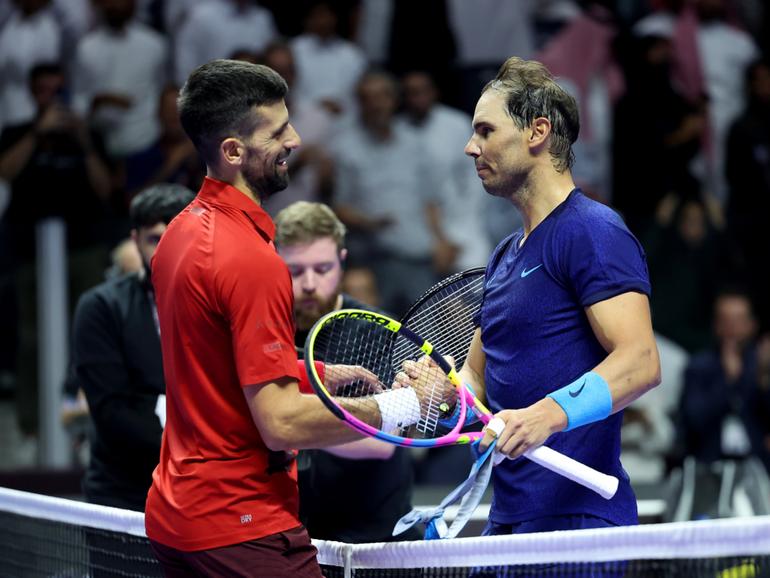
0,488,770,578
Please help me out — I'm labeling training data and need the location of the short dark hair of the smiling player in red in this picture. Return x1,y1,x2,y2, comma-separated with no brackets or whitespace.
177,59,289,164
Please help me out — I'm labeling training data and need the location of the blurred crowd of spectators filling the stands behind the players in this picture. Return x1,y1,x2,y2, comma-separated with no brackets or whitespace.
0,0,770,496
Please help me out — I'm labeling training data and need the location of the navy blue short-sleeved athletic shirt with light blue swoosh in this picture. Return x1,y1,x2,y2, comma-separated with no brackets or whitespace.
480,189,650,525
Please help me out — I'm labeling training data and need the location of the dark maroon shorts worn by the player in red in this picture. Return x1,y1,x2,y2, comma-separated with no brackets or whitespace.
150,526,323,578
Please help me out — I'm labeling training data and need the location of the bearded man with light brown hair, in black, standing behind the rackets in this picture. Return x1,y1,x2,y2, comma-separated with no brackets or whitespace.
275,201,421,543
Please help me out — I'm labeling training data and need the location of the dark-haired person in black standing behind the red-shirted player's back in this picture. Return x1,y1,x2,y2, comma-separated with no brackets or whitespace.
73,185,195,511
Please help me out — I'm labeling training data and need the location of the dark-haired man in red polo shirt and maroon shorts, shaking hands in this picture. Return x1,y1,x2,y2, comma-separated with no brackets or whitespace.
146,60,450,577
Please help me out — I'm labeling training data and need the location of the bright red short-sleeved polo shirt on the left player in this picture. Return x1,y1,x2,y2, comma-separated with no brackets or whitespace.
145,178,300,551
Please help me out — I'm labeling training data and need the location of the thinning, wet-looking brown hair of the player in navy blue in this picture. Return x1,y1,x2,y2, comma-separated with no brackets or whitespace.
482,56,580,172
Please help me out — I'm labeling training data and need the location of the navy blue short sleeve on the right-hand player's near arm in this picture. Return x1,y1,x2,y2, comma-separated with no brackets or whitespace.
551,208,650,307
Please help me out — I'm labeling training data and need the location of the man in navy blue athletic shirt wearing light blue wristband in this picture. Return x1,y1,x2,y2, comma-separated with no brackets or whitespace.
461,57,660,535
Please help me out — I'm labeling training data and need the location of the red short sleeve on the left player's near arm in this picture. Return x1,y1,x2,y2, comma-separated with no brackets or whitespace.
215,249,299,387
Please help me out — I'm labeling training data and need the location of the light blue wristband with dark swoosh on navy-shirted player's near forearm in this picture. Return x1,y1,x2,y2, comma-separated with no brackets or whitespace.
547,371,612,431
